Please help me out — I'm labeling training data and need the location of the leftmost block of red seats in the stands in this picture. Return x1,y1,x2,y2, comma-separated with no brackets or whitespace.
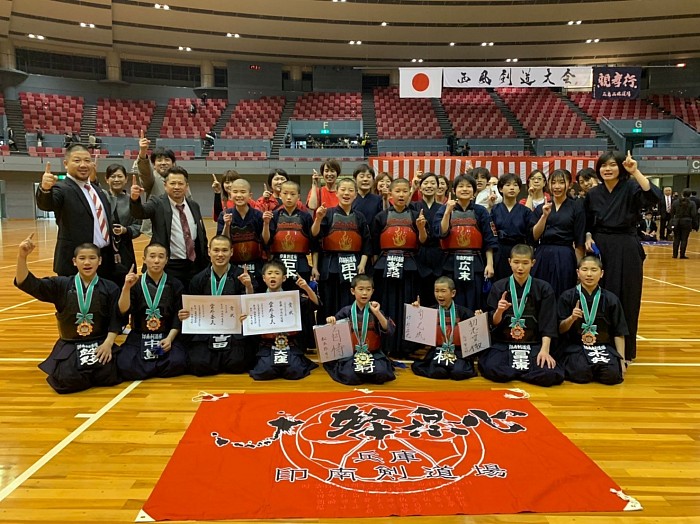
19,93,84,135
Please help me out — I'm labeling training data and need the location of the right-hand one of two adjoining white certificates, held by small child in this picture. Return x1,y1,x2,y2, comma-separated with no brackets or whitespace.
241,291,301,335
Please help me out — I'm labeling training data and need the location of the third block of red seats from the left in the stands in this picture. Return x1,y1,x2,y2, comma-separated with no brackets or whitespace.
160,98,227,138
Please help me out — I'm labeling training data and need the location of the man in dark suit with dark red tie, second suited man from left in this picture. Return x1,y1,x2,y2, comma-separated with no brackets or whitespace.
129,166,209,290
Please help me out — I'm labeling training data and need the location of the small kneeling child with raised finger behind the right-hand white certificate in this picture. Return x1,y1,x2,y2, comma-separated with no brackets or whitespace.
249,260,319,380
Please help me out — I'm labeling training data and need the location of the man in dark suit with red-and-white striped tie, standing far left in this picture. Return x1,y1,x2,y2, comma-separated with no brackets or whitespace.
36,144,114,279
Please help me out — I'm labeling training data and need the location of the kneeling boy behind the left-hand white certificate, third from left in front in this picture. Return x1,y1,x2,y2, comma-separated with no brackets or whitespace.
178,235,255,377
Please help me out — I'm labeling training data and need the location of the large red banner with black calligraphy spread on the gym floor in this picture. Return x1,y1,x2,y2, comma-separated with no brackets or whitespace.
142,391,628,520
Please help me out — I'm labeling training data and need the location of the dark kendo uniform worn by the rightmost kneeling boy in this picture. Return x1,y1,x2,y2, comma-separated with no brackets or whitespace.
557,288,627,385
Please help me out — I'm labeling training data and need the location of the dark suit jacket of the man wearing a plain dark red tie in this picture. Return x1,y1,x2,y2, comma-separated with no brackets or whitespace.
129,195,209,271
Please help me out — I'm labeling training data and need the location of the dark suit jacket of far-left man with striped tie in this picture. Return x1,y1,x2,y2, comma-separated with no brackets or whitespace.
36,178,114,278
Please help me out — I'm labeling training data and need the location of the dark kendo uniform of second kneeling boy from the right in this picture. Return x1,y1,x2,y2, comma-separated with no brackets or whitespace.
478,278,564,387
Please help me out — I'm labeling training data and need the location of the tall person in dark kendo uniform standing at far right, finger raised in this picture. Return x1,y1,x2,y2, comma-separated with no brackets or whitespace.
584,151,663,360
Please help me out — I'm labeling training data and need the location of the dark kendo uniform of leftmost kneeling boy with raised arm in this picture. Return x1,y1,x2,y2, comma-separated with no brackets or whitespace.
15,272,121,393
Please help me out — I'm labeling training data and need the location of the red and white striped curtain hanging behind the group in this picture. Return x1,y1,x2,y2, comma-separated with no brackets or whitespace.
369,156,596,182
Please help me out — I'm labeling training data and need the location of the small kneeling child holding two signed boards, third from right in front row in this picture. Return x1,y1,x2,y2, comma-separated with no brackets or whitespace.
411,277,476,380
